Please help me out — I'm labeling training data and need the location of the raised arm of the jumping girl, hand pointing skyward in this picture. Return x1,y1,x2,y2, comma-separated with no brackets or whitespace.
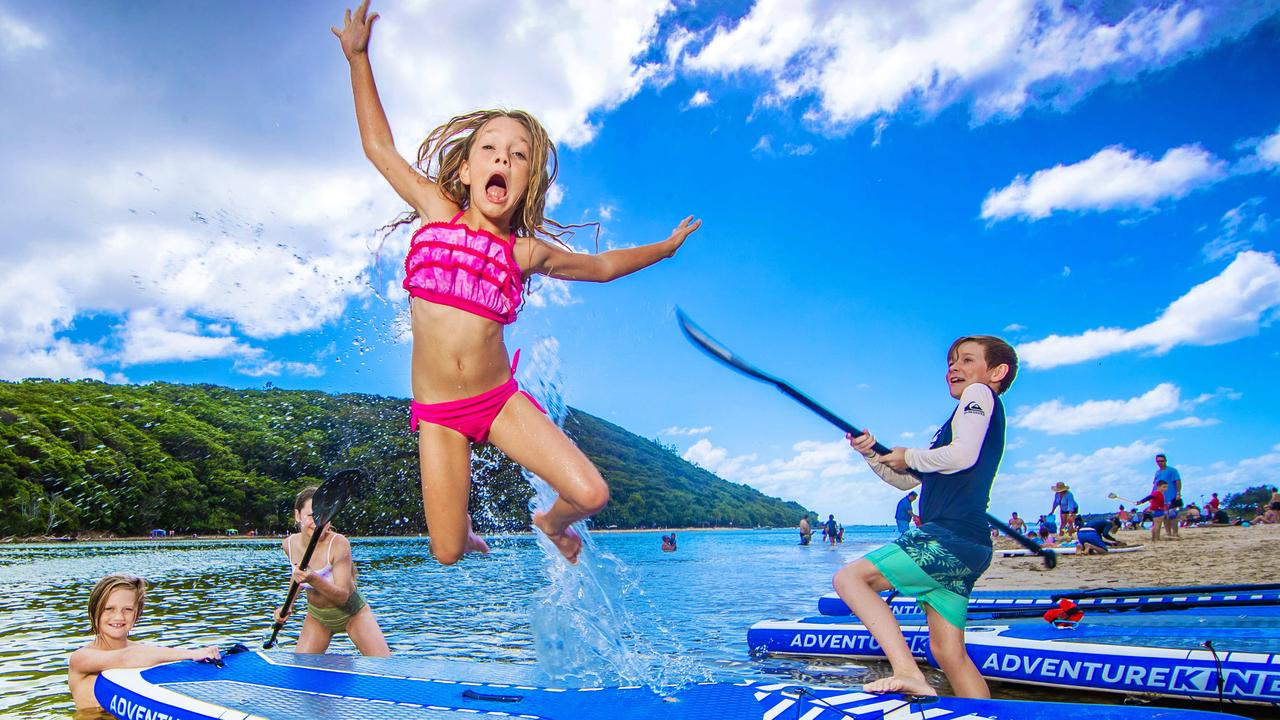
330,0,451,220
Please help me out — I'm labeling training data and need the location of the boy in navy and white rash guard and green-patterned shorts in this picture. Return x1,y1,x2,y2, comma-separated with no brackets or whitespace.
832,336,1018,698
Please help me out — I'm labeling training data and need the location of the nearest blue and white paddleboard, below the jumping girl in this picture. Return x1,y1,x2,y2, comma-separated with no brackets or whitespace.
95,652,1244,720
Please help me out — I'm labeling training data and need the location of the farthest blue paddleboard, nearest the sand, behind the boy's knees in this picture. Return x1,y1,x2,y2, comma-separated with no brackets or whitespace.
818,584,1280,616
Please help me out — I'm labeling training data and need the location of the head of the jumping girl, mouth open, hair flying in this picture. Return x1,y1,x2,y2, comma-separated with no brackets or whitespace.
417,110,559,236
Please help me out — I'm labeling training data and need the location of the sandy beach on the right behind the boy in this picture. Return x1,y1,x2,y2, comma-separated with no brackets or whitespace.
977,525,1280,589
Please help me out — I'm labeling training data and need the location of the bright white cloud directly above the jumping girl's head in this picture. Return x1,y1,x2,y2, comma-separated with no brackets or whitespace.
371,0,687,148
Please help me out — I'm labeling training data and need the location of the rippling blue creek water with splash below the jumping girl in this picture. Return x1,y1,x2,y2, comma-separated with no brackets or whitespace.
0,528,1261,719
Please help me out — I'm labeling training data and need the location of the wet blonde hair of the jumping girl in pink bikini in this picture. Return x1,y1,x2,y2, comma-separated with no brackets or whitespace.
387,110,581,241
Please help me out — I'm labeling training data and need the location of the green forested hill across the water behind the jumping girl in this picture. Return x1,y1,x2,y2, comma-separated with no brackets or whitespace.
0,380,806,537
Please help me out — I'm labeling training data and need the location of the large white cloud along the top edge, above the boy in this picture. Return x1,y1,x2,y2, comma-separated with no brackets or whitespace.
684,0,1271,129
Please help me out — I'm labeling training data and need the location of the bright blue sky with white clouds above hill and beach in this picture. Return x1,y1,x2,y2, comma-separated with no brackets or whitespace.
0,0,1280,523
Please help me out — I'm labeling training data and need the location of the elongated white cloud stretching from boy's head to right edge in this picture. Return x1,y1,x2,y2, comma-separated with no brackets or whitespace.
1018,250,1280,369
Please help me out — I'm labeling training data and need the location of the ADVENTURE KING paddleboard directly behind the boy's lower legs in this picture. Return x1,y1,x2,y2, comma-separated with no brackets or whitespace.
748,607,1280,705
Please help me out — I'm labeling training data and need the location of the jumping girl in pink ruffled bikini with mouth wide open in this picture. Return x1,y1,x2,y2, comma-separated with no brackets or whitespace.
333,0,701,565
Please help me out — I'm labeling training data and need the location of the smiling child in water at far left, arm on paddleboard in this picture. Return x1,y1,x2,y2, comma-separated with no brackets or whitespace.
67,575,221,720
